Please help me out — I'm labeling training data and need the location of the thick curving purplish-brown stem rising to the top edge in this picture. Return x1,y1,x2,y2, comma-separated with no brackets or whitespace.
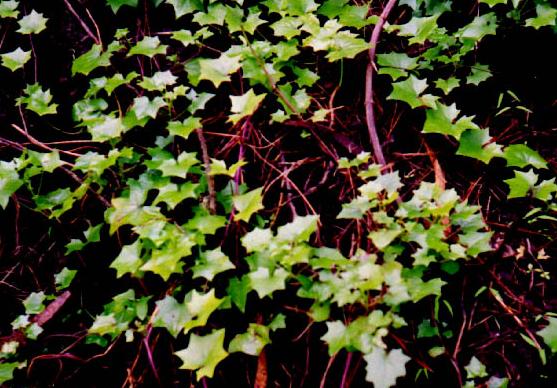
365,0,396,166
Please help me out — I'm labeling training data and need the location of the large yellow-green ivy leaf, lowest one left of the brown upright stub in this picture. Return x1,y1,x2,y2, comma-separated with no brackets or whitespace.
174,329,228,380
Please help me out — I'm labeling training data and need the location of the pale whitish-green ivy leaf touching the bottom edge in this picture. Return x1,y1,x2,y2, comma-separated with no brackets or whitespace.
364,346,410,388
